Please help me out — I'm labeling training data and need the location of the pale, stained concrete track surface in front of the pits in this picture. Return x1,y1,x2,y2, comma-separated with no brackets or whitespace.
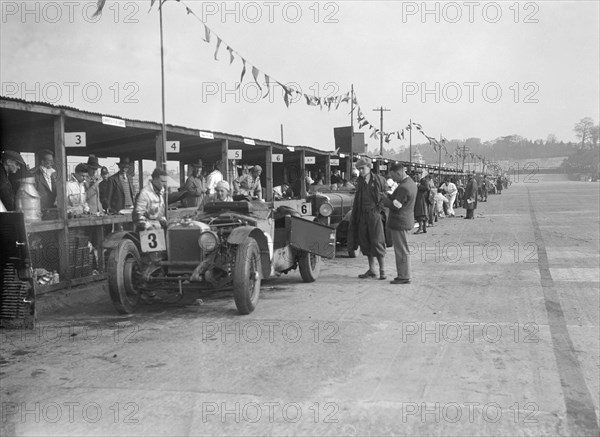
0,175,600,436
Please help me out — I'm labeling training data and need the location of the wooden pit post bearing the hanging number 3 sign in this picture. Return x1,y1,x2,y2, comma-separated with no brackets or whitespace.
54,115,71,281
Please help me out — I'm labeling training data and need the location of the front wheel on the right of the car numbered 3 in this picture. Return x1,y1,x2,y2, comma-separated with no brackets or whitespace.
233,238,262,314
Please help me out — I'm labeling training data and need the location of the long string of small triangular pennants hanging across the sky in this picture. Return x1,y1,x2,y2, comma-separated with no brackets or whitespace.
94,0,484,164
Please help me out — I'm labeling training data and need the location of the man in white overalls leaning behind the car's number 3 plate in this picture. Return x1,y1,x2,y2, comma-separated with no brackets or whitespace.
133,167,167,231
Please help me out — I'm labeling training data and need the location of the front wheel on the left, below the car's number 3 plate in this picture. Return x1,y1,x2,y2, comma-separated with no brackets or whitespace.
108,240,141,314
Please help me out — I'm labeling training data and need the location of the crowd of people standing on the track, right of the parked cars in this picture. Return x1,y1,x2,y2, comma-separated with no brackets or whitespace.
347,158,509,284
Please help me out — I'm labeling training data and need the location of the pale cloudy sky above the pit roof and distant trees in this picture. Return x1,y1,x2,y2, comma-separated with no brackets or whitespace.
0,0,600,150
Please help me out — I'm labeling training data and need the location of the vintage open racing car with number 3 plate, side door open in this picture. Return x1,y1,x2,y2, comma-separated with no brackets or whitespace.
104,201,335,314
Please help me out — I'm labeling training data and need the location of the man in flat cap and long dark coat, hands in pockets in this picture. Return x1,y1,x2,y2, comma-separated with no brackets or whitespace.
348,158,387,279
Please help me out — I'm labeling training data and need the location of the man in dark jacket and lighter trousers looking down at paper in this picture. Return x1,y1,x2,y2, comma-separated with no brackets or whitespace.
383,163,417,284
